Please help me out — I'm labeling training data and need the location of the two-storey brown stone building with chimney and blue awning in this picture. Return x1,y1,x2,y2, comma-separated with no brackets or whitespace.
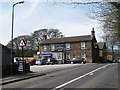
39,28,99,62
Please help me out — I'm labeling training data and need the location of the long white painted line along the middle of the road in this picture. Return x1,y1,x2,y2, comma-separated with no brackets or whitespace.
52,64,110,90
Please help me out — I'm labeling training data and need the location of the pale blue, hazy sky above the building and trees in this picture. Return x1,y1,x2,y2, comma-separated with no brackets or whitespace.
0,0,101,45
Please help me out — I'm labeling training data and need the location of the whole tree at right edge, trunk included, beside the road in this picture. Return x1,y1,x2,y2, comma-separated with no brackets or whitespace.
87,2,120,60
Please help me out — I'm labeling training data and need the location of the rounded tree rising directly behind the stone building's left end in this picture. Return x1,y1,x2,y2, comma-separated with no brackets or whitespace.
32,28,62,50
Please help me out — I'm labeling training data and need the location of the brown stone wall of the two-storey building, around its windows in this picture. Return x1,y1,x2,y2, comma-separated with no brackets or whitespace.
41,40,99,62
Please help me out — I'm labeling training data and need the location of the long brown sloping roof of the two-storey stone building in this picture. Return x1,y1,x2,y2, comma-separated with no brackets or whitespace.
41,35,91,44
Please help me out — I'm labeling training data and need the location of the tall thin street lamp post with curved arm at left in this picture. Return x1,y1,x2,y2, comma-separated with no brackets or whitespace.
11,1,24,74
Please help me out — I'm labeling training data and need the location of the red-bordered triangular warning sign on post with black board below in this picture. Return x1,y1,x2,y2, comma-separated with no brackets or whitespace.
18,39,26,73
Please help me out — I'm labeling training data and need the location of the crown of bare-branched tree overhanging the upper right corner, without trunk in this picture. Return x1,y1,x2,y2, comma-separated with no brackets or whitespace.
89,2,120,38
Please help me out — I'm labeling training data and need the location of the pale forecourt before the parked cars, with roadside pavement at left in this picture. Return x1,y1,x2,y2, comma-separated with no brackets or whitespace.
0,64,86,85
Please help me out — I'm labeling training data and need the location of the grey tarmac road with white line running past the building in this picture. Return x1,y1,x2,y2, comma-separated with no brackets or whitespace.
2,64,120,90
